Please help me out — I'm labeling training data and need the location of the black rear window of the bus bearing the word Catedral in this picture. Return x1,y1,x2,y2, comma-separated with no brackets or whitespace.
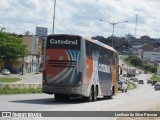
46,35,81,50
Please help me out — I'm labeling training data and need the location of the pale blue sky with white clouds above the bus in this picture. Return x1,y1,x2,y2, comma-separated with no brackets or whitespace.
0,0,160,38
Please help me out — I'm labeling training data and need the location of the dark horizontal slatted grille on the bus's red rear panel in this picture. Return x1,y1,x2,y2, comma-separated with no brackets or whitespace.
48,60,77,67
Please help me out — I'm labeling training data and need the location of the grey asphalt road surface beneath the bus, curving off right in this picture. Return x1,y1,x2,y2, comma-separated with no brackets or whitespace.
0,74,160,120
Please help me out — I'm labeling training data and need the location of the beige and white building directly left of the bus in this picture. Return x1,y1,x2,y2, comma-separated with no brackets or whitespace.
22,35,44,73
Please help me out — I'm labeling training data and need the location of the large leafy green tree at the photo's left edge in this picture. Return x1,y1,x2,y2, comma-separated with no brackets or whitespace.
0,32,28,63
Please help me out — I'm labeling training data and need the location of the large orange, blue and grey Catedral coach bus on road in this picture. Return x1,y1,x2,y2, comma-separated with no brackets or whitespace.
42,34,119,102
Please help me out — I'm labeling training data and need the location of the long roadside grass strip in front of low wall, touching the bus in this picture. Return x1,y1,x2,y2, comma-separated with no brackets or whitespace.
0,85,42,95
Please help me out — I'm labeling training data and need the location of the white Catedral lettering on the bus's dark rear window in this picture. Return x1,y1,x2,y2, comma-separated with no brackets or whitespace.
50,39,78,45
